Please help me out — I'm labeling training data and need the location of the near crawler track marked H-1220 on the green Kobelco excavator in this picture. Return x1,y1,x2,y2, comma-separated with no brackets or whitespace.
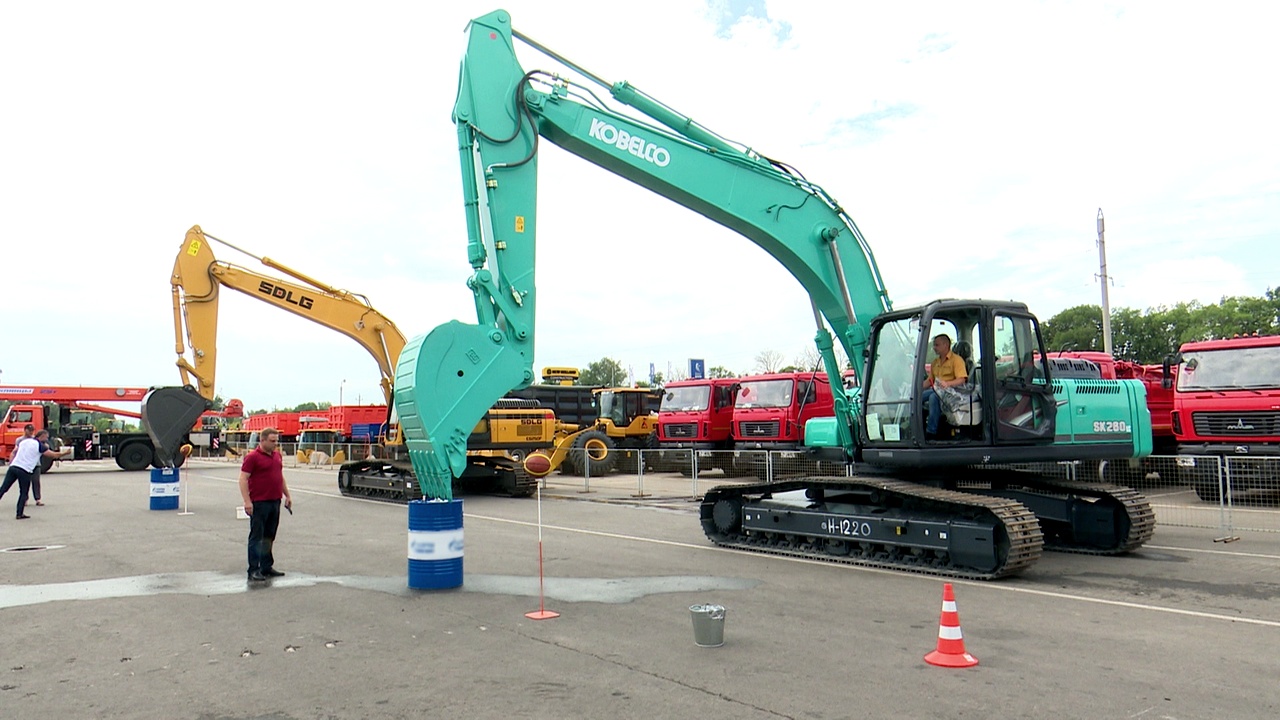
700,477,1043,580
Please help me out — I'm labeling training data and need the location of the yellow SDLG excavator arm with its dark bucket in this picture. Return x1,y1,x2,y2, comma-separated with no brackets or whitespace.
142,225,404,461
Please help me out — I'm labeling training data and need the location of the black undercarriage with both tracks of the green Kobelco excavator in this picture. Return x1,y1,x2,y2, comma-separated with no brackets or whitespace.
700,470,1155,580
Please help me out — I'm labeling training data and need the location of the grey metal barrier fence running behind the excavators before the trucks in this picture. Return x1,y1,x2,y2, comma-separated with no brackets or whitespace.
215,443,1280,539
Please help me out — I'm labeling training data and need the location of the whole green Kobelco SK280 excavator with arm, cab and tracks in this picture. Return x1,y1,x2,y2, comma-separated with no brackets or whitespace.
396,10,1155,579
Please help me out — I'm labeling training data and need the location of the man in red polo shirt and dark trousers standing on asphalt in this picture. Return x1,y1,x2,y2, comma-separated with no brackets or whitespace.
239,428,293,582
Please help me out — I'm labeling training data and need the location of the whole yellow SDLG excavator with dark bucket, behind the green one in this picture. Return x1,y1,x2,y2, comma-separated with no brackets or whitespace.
142,225,556,491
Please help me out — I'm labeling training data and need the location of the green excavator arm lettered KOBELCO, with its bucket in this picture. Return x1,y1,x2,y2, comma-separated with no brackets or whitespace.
396,10,890,495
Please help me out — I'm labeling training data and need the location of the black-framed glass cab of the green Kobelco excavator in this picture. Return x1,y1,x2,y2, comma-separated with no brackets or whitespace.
859,300,1056,465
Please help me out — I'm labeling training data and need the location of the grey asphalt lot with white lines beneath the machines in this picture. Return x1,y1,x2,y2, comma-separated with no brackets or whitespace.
0,460,1280,719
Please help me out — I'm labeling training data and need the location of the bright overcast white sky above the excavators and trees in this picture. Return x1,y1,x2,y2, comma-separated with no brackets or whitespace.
0,0,1280,409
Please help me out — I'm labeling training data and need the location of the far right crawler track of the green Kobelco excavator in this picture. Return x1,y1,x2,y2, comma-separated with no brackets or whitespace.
960,470,1156,555
